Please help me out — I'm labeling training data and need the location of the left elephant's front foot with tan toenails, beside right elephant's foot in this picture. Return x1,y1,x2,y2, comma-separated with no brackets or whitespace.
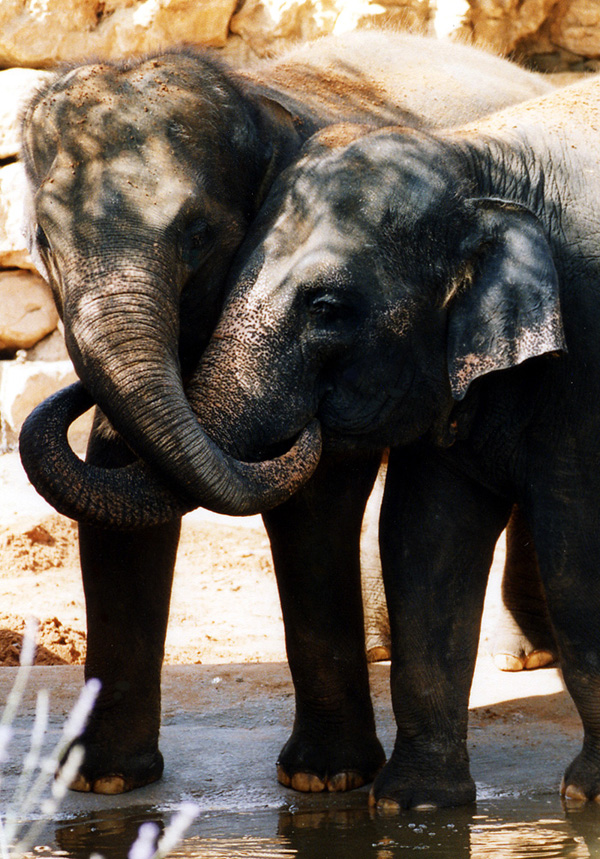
277,730,385,793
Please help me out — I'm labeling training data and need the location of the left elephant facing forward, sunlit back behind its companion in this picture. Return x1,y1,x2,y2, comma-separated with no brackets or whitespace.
21,32,552,793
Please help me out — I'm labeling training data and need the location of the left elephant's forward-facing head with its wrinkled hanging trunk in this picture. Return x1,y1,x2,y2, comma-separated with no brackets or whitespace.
22,52,318,524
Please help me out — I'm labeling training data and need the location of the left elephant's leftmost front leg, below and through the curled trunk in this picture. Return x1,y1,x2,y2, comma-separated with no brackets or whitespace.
72,420,181,793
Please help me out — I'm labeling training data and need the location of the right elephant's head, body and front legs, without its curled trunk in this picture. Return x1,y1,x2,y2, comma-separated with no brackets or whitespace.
139,79,600,809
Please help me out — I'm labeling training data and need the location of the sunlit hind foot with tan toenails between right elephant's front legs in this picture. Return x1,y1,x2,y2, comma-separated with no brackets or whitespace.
492,609,558,671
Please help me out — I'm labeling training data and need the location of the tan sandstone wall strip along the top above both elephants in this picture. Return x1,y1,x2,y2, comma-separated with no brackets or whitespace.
0,0,600,70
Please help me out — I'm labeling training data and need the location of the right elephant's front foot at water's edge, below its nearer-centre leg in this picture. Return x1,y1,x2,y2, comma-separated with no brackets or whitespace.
369,750,475,816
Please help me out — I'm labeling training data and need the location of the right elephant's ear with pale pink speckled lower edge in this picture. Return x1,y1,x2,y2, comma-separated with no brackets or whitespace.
448,198,566,400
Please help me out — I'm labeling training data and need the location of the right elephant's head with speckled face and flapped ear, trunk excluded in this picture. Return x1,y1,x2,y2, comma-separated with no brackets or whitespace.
18,127,564,520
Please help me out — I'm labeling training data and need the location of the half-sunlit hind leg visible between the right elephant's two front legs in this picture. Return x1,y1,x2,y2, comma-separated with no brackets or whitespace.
492,507,557,671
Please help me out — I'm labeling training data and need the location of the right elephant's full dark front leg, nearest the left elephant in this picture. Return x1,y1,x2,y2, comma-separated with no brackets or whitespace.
371,447,510,812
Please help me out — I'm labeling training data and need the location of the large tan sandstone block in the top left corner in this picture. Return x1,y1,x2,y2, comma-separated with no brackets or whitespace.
0,0,236,67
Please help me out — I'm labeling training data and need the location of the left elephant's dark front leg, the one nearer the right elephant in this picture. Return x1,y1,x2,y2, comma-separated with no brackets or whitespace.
264,454,385,791
